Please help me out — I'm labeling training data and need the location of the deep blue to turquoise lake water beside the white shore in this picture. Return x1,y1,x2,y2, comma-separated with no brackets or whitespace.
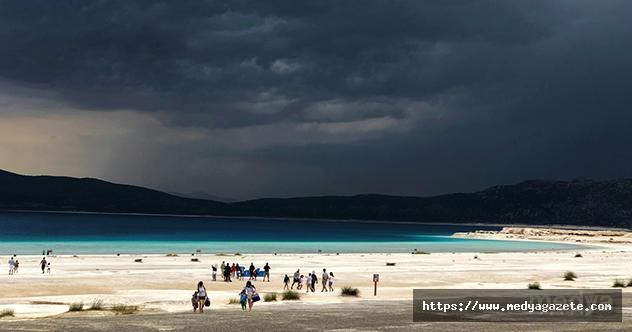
0,212,581,255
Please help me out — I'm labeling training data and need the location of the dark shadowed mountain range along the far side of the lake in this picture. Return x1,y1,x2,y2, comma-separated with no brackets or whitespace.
0,170,632,228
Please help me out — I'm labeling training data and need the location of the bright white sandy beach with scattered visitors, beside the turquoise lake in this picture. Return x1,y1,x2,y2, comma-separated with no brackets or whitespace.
0,228,632,320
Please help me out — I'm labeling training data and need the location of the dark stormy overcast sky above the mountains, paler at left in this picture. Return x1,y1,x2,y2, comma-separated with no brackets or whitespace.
0,0,632,199
